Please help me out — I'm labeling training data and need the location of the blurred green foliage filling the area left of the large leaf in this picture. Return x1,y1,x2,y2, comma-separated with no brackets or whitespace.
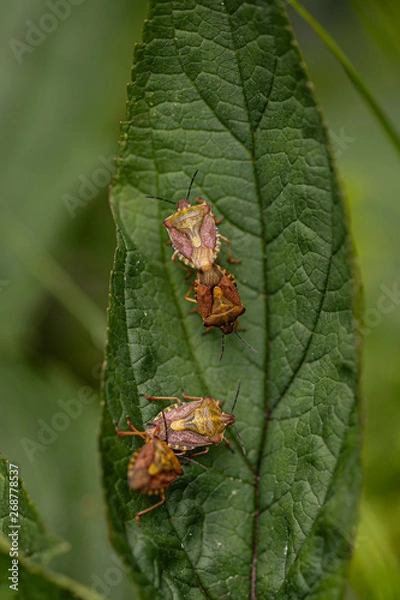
0,0,145,598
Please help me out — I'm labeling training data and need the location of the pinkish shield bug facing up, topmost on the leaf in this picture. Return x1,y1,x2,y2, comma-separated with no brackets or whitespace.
147,171,240,269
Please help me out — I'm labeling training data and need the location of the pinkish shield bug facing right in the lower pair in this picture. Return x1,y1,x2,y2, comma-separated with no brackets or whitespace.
141,381,245,456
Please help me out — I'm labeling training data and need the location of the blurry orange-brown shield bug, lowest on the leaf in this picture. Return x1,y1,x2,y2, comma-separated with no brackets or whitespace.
114,417,183,526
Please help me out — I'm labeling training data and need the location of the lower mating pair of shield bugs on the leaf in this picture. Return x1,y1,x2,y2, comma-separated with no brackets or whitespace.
115,382,244,525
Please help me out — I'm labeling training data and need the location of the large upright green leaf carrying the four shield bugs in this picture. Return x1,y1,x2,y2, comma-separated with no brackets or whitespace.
101,0,360,599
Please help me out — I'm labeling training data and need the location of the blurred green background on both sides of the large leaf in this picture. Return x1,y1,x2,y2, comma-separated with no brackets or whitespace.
0,0,400,600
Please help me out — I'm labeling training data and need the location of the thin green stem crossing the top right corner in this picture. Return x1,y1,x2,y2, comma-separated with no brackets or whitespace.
288,0,400,154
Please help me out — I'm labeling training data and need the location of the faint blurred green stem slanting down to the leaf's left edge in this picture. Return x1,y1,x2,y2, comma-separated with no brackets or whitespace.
0,211,107,351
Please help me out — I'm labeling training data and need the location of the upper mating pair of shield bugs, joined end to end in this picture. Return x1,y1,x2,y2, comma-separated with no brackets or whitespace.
148,171,255,358
